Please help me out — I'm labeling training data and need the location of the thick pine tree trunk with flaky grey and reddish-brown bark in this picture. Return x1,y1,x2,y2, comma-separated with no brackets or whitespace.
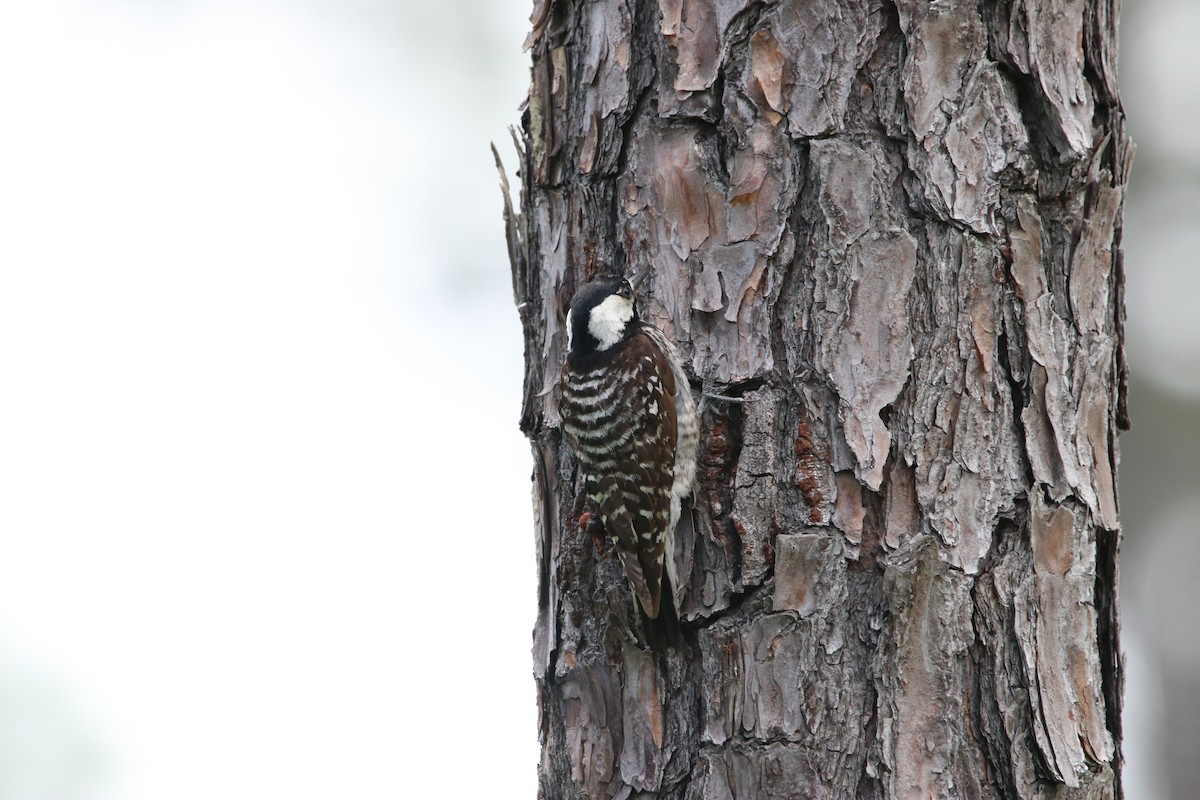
505,0,1132,800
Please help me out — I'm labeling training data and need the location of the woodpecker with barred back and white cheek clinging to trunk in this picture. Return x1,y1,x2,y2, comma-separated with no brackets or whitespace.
559,273,700,619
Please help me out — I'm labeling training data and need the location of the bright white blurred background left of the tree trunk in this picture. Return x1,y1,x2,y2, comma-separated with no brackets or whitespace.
0,0,538,800
